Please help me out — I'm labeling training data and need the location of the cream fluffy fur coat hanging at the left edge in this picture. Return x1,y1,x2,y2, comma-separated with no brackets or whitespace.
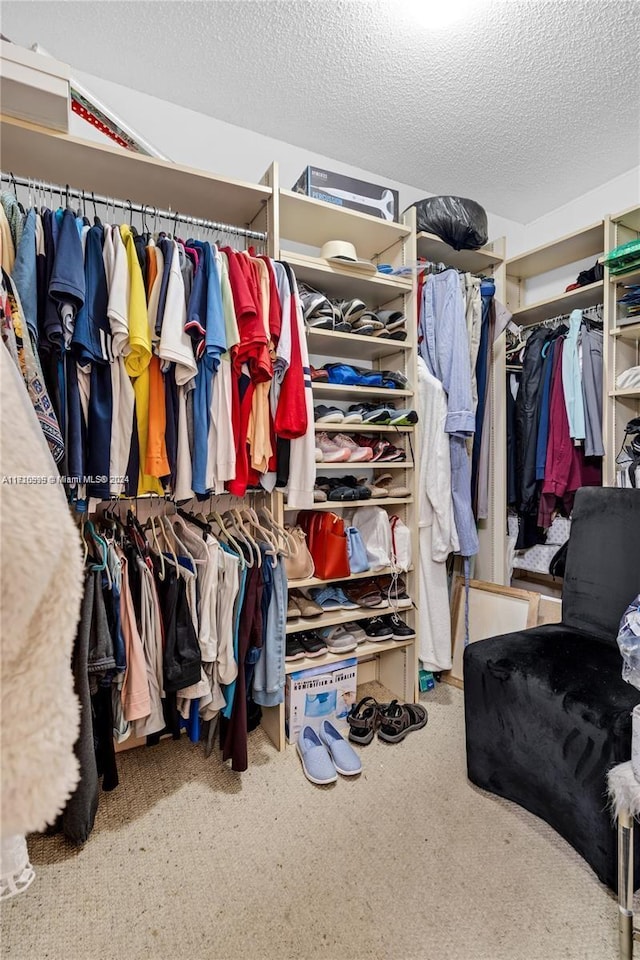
0,340,83,836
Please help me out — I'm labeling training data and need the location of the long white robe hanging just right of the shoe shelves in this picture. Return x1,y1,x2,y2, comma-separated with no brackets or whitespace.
418,357,459,671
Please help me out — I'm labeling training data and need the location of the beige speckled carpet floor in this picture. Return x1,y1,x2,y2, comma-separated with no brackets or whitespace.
1,685,617,960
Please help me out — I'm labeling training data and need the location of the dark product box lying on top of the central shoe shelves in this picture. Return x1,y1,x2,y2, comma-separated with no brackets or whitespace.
293,167,400,224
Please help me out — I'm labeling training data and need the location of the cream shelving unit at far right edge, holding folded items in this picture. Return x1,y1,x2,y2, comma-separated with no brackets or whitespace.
603,206,640,486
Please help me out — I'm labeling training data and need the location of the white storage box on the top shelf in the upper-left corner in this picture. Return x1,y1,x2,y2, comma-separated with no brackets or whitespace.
0,40,71,132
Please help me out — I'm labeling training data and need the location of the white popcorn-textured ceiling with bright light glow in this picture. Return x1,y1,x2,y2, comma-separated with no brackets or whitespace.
2,0,640,222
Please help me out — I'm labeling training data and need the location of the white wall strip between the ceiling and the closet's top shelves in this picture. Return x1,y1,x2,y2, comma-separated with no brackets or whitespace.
71,70,522,251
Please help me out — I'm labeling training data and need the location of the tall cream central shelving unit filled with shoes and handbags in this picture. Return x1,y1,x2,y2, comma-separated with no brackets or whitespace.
262,190,418,749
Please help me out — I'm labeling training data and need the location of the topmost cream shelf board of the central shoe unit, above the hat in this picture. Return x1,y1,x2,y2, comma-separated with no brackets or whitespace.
280,189,411,260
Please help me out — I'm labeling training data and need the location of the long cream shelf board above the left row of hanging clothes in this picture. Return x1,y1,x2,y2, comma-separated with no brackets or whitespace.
0,117,272,226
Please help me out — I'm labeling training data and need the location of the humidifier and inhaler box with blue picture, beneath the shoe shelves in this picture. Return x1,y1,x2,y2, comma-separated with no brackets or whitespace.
285,657,358,743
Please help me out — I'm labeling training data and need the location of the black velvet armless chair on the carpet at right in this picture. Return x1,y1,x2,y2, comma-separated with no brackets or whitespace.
464,487,640,890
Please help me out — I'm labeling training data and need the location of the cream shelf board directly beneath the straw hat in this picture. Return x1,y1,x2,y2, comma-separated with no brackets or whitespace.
280,250,413,307
